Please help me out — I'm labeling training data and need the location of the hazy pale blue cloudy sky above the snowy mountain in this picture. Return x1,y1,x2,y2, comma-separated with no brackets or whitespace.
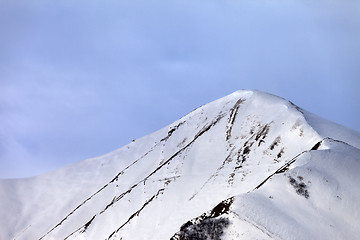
0,0,360,178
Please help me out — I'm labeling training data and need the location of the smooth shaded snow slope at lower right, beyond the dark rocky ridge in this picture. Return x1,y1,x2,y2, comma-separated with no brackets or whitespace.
222,139,360,239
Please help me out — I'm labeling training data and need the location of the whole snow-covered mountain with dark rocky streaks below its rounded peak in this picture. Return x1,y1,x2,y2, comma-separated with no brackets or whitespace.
0,91,360,240
